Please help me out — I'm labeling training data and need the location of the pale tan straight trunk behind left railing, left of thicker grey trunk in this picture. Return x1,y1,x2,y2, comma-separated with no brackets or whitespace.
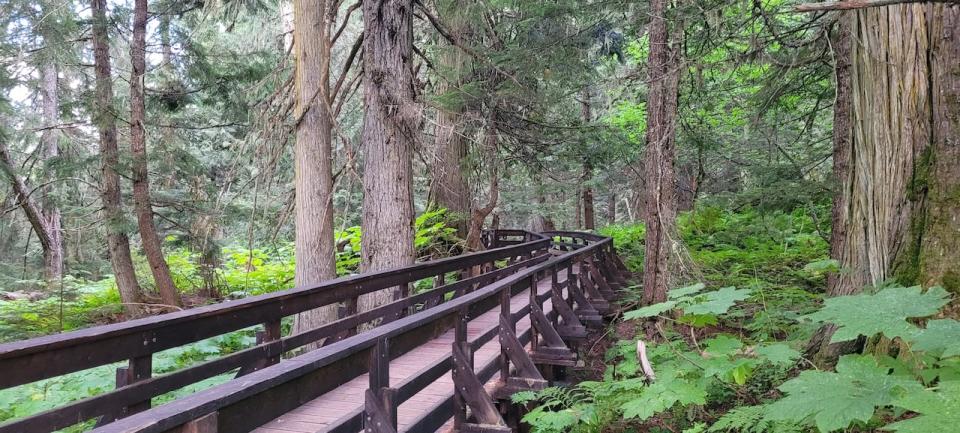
293,0,337,340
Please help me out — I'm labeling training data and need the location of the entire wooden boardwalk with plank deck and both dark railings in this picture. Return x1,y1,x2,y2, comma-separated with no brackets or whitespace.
0,229,632,433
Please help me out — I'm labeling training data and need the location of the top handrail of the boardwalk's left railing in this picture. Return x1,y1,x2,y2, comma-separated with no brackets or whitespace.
0,228,550,389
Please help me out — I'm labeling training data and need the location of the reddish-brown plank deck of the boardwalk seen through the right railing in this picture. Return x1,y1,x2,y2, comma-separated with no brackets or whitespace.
254,271,566,433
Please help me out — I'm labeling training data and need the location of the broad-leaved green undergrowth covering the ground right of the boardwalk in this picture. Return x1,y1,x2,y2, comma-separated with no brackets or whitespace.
514,209,960,433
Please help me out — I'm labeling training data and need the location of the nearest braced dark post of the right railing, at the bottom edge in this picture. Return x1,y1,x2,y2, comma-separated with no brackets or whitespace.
363,338,397,433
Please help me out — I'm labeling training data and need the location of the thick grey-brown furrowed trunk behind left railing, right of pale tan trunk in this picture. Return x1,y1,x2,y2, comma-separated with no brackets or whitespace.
358,0,420,311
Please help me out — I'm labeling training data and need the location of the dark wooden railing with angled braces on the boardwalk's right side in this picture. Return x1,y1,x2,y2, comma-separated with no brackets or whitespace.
88,231,625,433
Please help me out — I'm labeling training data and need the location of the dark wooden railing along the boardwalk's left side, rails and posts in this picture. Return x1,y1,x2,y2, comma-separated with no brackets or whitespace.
0,230,551,433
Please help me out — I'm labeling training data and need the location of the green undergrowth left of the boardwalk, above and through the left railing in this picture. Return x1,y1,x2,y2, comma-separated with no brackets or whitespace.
0,209,462,433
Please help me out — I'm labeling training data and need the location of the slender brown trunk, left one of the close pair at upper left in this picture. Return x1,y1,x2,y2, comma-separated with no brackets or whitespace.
90,0,141,316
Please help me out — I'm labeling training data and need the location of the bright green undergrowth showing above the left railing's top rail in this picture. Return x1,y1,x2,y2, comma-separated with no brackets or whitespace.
0,209,462,342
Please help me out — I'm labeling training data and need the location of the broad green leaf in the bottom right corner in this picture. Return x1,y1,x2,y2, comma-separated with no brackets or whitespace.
883,381,960,433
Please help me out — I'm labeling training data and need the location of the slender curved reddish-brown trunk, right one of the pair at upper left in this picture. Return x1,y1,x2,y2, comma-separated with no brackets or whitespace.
130,0,181,306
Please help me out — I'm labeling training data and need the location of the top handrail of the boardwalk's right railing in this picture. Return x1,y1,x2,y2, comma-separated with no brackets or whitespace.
93,232,611,433
